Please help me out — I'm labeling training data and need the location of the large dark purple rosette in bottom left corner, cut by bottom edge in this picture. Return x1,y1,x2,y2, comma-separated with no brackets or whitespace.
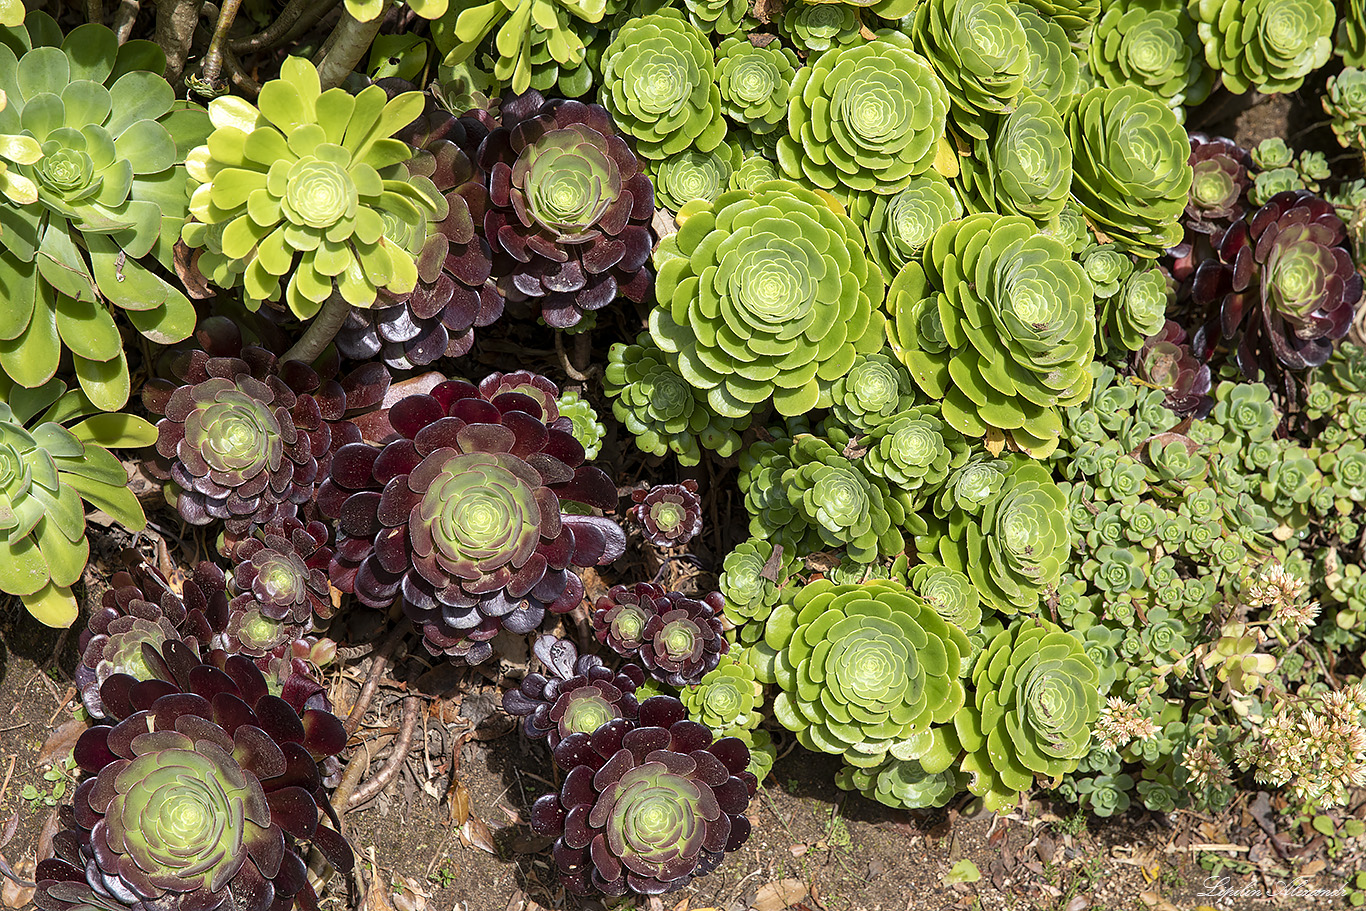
34,641,352,911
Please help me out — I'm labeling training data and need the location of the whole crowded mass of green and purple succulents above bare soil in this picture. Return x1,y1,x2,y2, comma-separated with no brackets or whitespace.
8,0,1366,911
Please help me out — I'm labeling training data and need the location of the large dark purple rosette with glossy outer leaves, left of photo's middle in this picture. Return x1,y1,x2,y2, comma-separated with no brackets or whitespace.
318,374,626,664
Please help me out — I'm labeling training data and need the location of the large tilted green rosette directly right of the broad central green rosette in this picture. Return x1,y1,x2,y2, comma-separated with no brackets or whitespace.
888,214,1096,458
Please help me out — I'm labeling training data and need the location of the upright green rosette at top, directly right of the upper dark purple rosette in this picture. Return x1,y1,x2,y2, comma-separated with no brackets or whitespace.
601,10,725,160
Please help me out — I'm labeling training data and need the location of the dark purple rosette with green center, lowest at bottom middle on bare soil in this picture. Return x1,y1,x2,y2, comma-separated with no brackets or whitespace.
531,697,758,895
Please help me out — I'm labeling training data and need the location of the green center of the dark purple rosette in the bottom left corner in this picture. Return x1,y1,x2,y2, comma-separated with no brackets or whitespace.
101,731,270,895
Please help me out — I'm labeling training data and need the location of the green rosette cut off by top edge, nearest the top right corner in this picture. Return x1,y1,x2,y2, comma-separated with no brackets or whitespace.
1188,0,1337,94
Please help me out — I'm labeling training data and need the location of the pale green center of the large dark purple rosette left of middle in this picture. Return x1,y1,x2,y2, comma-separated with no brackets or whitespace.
411,452,543,580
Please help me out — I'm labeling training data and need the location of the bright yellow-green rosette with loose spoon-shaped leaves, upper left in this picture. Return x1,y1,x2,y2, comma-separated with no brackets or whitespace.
183,57,449,320
